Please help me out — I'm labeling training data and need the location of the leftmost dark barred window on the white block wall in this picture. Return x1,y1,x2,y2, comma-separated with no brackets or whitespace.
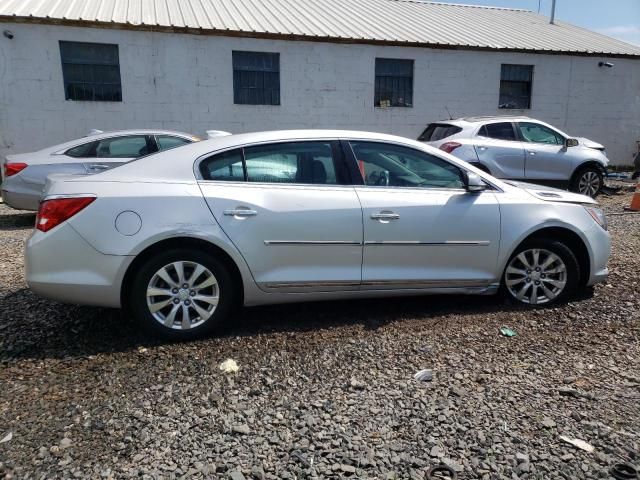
60,41,122,102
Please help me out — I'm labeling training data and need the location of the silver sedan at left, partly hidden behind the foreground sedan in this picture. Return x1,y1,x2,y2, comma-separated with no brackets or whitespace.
2,130,200,210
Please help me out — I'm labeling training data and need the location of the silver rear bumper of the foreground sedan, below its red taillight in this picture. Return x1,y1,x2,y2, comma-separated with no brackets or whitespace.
25,224,134,308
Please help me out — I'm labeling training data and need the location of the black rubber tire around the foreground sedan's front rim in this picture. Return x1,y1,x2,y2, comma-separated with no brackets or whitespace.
501,238,581,307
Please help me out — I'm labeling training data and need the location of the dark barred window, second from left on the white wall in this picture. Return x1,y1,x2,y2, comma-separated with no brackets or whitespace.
232,51,280,105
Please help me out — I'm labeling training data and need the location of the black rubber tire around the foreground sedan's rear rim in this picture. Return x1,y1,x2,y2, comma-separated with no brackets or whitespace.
128,248,239,341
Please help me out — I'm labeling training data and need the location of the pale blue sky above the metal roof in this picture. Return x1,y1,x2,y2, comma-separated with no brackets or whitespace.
442,0,640,45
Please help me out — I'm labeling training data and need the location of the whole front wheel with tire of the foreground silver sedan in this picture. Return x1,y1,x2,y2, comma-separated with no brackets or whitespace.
502,238,580,305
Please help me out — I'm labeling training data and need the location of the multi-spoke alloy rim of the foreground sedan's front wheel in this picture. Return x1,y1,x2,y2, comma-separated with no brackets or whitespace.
504,248,567,305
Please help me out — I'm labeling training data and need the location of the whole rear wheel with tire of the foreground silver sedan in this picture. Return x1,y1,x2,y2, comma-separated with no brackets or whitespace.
129,249,237,340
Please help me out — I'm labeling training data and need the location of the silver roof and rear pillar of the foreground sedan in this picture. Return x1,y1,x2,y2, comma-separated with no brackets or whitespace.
84,130,460,182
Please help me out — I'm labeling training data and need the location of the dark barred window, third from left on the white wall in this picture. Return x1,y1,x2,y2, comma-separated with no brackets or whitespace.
374,58,413,107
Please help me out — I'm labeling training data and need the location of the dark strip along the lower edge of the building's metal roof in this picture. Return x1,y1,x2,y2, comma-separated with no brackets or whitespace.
5,15,640,59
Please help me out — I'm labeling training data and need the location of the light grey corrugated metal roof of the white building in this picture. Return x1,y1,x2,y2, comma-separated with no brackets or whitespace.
0,0,640,57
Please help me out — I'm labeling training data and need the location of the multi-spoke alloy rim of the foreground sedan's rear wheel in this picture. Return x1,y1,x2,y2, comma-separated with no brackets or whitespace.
146,261,220,330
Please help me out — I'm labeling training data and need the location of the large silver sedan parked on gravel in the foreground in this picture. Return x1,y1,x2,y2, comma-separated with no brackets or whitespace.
26,130,610,339
